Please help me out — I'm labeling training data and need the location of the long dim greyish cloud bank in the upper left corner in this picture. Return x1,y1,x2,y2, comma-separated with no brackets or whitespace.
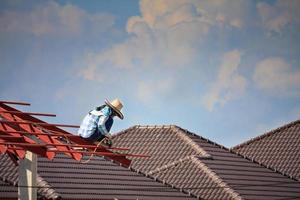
0,1,114,36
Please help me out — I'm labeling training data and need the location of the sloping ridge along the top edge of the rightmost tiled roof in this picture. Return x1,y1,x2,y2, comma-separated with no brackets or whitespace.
230,119,300,150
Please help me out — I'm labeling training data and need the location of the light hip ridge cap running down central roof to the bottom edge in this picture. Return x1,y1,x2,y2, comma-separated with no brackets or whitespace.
191,156,242,200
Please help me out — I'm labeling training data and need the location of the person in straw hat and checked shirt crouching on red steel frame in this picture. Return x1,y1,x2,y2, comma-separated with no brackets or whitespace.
78,99,124,146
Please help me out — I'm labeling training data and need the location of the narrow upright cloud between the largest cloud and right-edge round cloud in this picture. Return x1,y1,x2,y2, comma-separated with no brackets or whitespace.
203,50,246,111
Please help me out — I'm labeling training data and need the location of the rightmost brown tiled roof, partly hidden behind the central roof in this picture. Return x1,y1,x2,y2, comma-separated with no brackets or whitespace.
232,120,300,181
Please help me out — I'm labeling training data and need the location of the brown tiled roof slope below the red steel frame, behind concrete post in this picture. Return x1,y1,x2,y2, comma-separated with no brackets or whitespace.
0,154,195,200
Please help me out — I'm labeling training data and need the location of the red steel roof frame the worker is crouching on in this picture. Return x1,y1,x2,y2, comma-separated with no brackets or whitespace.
0,101,148,167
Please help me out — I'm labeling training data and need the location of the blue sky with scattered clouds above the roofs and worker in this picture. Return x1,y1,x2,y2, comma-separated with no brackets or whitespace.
0,0,300,147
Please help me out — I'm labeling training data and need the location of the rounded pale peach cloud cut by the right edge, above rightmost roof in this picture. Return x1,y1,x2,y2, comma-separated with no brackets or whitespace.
253,57,300,96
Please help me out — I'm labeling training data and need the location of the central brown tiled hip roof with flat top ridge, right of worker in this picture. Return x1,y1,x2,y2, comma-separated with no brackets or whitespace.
113,126,300,199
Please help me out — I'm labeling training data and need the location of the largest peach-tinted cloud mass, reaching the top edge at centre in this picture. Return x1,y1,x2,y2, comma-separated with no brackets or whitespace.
80,0,247,79
